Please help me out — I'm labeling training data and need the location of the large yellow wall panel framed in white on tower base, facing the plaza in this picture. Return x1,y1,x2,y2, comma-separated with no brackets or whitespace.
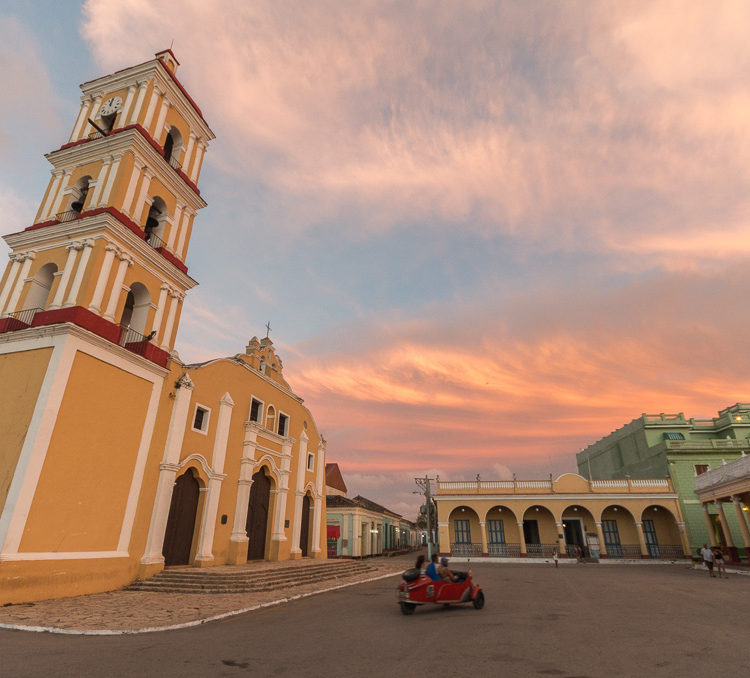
19,352,151,552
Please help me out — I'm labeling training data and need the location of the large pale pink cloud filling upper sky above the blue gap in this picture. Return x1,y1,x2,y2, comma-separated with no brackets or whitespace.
83,0,750,268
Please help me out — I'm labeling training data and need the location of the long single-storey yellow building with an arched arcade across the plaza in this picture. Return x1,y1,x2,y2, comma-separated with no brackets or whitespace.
434,473,690,560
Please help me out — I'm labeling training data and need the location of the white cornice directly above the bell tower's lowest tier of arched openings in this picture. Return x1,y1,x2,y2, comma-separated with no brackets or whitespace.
3,212,198,290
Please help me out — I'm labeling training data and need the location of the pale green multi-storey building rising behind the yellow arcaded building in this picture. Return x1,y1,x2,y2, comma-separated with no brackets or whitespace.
576,403,750,557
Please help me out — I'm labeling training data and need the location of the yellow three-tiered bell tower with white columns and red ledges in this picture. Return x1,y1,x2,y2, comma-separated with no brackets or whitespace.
0,50,214,596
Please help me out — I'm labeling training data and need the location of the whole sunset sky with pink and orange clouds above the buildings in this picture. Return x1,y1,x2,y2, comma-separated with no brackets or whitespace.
0,0,750,514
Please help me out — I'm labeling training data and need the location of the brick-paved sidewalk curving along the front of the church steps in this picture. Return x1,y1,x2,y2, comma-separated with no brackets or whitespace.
0,554,416,634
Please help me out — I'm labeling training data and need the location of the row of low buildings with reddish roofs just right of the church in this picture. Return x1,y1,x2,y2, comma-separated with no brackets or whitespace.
326,463,419,558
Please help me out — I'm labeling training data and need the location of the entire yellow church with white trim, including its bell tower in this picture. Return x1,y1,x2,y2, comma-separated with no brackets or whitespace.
0,50,326,603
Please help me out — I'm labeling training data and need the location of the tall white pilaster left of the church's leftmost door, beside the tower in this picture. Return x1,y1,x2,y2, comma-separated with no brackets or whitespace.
141,374,194,565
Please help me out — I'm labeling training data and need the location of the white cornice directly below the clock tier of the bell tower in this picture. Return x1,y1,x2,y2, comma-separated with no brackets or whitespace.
44,128,206,211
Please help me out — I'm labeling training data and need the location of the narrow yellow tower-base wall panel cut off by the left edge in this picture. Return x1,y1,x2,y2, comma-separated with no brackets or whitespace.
0,348,52,506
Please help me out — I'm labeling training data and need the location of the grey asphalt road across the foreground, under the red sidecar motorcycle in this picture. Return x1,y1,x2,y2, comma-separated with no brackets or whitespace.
0,564,750,678
